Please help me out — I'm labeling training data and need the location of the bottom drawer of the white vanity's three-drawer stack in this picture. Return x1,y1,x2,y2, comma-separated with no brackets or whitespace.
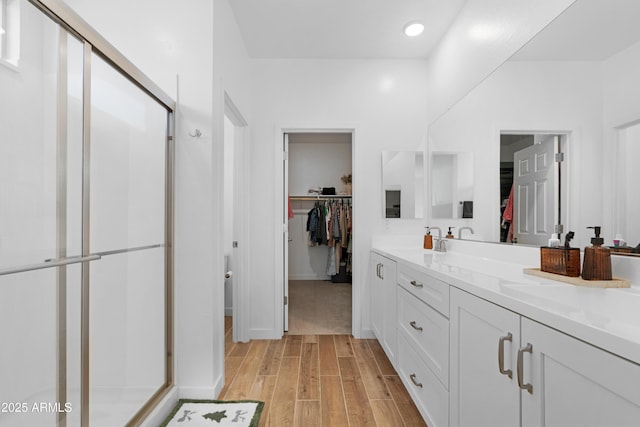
398,334,449,427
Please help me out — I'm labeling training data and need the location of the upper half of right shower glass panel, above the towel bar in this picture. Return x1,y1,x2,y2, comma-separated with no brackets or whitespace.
91,55,167,253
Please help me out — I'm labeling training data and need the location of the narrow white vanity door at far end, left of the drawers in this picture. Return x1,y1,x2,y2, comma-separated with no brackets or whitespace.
371,252,397,366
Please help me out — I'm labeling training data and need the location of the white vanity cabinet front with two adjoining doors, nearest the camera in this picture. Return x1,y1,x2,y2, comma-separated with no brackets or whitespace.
450,288,640,427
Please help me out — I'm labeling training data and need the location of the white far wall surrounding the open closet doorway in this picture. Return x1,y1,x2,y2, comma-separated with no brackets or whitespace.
249,60,427,338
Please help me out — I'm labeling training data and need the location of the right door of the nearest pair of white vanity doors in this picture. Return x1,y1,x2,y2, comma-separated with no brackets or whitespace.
522,318,640,427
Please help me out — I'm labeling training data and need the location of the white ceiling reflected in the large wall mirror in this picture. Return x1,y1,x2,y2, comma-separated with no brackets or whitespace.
512,0,640,61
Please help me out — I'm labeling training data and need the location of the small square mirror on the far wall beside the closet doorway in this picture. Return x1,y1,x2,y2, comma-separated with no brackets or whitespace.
382,151,424,219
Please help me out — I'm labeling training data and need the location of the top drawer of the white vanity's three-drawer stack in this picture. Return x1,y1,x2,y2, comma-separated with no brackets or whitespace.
398,265,449,318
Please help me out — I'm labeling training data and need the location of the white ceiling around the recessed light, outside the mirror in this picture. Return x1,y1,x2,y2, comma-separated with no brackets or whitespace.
229,0,466,59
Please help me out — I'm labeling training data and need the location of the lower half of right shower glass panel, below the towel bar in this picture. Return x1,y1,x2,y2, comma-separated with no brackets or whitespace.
89,248,165,427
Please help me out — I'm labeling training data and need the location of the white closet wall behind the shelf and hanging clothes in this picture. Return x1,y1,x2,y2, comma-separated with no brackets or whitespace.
289,133,352,280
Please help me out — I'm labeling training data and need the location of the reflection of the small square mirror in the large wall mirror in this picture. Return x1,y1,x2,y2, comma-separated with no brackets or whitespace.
429,151,473,219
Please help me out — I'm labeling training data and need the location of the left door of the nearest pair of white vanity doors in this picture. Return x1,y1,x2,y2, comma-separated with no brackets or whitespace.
449,287,520,427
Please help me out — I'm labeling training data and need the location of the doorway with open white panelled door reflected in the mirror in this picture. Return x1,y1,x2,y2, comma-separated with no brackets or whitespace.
500,134,562,246
